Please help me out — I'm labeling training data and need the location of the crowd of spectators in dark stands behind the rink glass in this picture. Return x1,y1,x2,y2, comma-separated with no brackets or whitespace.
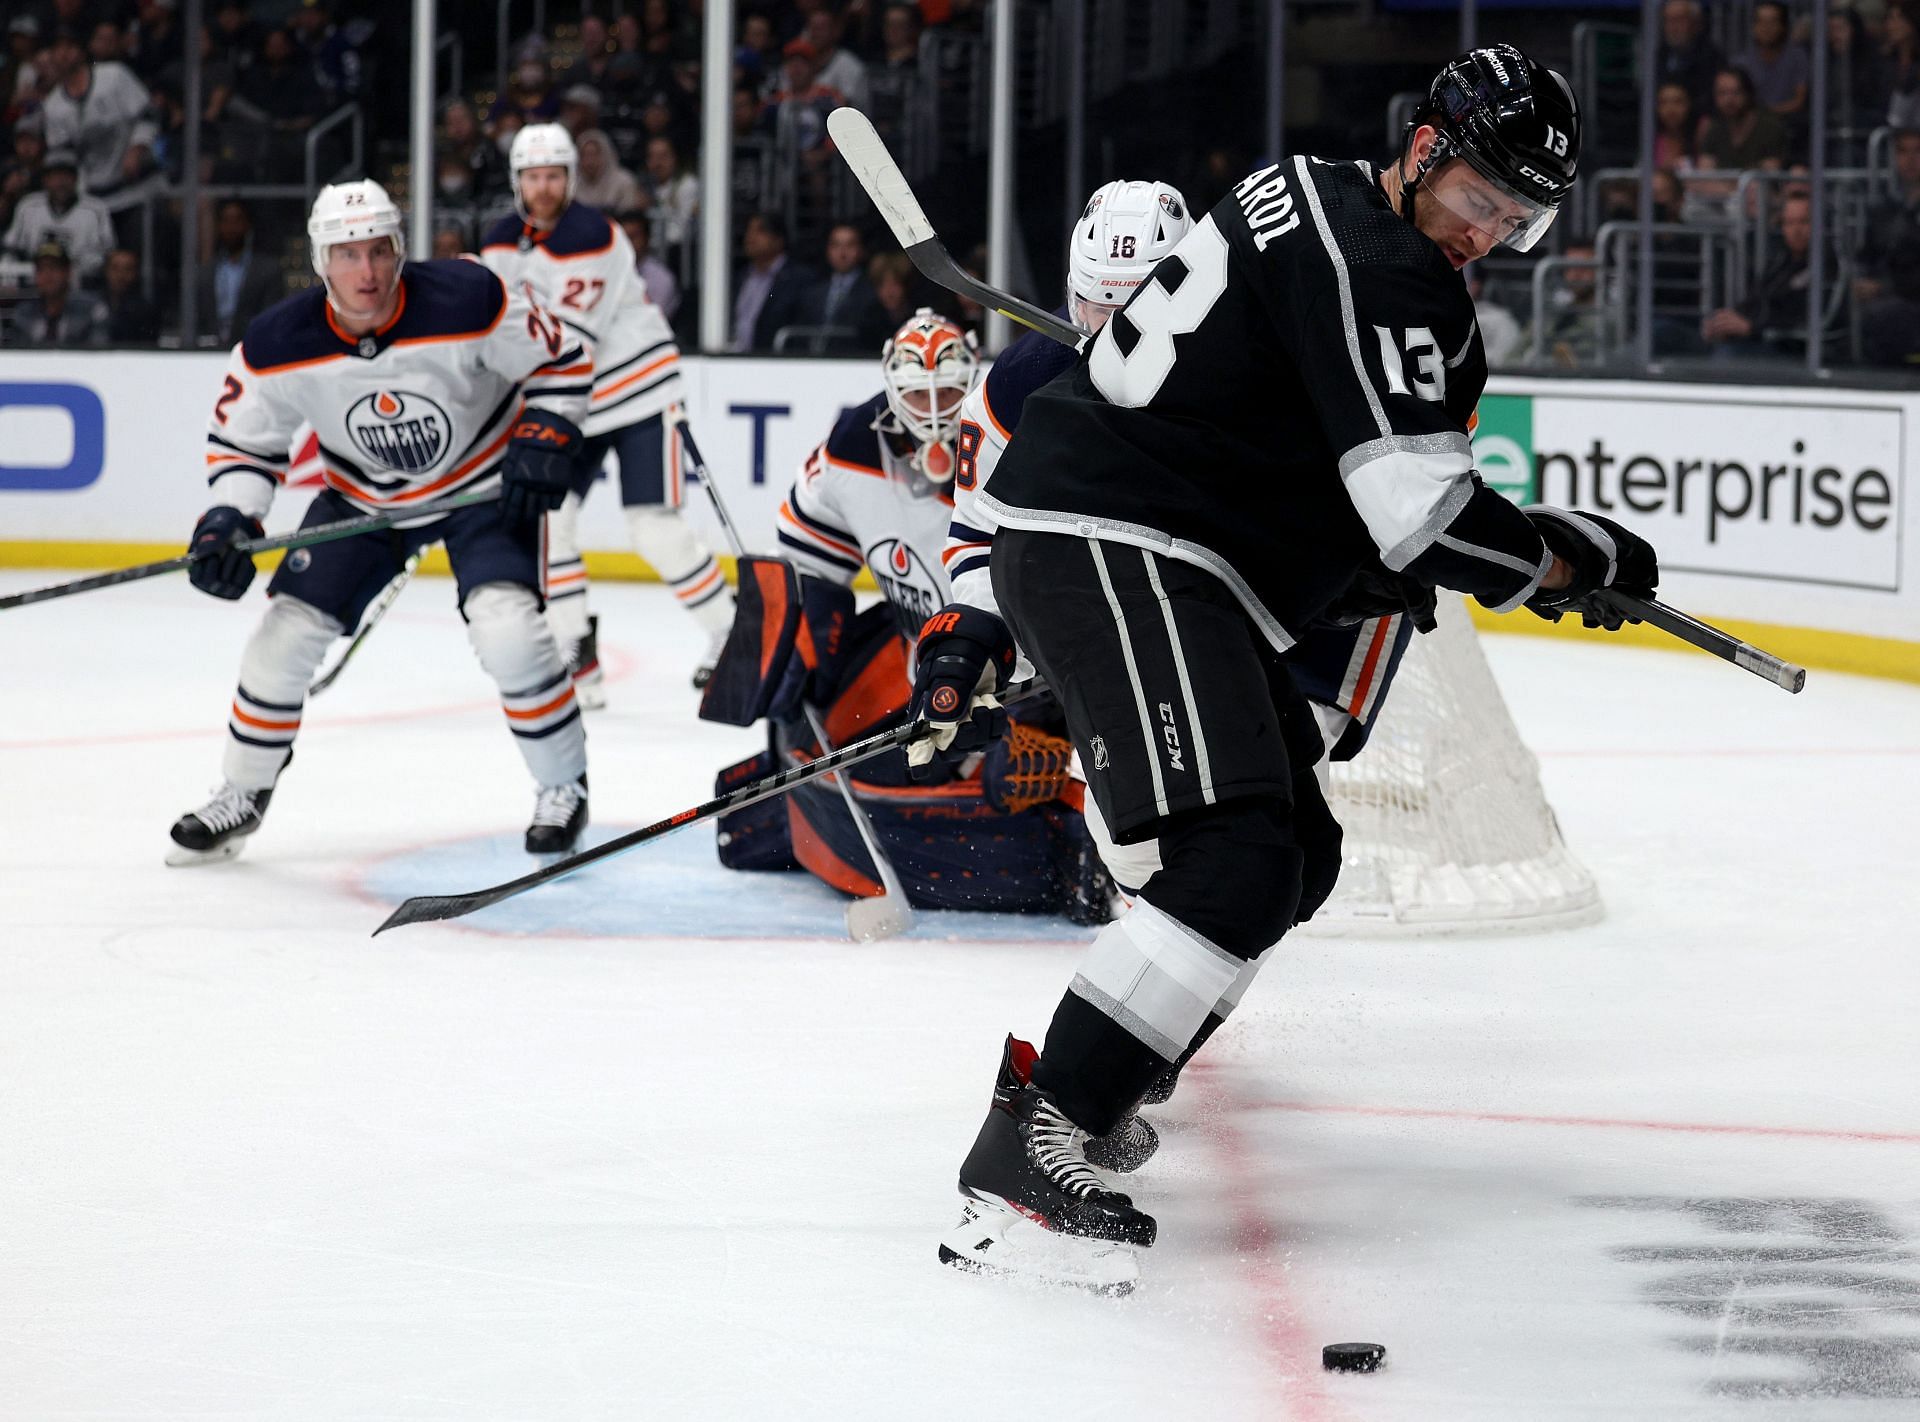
0,0,1920,365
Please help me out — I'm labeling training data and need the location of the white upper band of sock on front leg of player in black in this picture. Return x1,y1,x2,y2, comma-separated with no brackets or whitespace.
1068,898,1242,1061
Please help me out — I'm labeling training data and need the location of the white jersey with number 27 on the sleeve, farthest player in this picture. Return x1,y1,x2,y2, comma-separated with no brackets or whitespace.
480,203,685,436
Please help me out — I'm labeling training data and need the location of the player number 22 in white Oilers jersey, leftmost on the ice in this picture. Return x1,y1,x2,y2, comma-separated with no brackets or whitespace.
169,180,593,864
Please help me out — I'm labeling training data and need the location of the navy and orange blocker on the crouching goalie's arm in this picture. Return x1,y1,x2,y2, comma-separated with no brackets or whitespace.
701,555,852,725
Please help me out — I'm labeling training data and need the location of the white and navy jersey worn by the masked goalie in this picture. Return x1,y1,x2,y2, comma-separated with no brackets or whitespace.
778,393,954,637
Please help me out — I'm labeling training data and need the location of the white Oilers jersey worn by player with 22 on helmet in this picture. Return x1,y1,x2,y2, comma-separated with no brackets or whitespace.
207,261,593,518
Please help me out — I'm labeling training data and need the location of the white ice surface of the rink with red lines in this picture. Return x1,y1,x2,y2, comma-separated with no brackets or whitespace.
0,570,1920,1422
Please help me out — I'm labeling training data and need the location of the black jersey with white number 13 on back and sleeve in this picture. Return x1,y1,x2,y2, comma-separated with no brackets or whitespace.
981,157,1551,651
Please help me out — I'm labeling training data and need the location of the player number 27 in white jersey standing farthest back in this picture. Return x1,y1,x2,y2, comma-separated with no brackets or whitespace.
480,123,733,694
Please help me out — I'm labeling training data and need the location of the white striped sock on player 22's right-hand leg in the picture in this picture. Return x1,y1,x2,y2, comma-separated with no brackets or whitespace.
463,583,588,785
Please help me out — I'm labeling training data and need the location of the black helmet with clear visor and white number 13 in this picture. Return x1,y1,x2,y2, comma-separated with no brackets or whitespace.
1404,44,1580,251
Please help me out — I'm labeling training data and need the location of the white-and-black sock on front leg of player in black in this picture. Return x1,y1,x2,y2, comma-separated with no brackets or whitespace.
1033,898,1242,1136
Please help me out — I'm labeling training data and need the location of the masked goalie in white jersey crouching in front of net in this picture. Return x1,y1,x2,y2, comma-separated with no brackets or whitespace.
701,309,1110,921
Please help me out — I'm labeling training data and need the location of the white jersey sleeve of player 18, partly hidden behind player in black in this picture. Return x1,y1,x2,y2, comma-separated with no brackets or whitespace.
941,330,1079,614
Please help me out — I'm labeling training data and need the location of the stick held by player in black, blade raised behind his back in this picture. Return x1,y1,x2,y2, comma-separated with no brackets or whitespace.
828,109,1807,693
